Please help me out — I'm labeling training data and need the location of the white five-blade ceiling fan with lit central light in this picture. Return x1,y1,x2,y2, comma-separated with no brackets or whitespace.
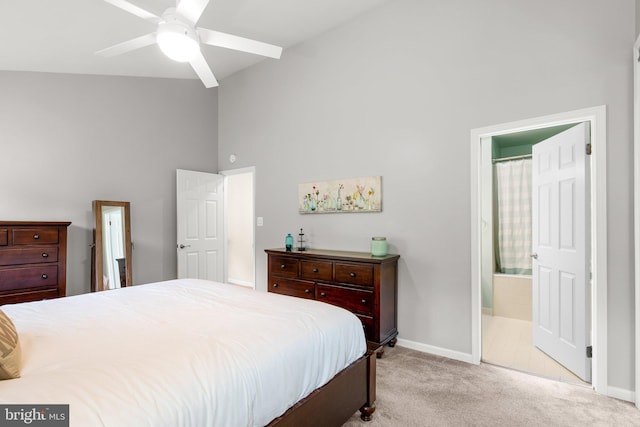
96,0,282,88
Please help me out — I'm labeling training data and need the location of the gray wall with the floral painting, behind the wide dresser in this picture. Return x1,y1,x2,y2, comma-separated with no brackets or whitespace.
218,0,635,390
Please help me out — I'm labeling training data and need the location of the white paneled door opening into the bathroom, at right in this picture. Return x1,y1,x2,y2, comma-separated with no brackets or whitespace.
532,122,591,382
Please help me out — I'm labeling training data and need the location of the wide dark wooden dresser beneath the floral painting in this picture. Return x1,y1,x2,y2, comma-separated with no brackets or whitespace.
265,249,400,357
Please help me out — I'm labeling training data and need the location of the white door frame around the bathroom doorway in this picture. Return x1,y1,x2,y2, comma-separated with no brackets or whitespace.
470,105,608,395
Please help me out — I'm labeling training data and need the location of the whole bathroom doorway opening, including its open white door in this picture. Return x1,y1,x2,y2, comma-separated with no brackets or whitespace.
481,123,591,383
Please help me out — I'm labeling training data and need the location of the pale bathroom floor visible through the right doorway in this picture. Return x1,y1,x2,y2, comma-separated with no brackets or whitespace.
482,314,586,385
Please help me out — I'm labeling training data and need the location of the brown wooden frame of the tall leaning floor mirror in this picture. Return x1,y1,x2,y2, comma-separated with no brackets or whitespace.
91,200,133,292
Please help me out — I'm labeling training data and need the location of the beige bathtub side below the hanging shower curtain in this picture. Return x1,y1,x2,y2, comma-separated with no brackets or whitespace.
493,273,533,322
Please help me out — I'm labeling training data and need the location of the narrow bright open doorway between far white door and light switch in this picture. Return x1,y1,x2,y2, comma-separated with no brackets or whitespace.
220,168,255,288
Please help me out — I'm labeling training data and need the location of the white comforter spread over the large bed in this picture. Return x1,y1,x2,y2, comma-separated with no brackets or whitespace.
0,279,366,427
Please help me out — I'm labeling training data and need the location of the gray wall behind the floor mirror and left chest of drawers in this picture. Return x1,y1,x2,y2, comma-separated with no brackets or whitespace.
0,72,218,295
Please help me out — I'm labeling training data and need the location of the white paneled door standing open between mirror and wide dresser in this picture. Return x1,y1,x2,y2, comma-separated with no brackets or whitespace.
176,169,224,282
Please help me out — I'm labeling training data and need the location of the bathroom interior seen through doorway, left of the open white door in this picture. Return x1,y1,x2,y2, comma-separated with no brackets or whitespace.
481,123,590,382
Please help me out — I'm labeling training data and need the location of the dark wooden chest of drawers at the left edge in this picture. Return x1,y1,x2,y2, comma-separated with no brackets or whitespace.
0,221,71,305
